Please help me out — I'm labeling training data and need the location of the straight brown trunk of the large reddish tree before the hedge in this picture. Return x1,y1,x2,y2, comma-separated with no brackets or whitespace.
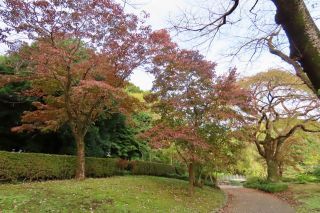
75,135,86,180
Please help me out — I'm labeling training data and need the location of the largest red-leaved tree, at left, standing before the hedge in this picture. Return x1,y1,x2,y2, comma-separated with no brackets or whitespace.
0,0,150,179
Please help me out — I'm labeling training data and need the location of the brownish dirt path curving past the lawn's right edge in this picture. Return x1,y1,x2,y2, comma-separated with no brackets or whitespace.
221,186,295,213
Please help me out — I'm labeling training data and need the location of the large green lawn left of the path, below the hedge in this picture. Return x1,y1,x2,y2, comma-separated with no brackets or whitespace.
0,176,224,212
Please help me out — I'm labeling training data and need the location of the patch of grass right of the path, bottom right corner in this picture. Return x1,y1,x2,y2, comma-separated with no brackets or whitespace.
289,184,320,213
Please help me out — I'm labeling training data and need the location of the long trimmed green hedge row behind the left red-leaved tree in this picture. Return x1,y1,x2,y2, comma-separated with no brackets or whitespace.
0,152,184,182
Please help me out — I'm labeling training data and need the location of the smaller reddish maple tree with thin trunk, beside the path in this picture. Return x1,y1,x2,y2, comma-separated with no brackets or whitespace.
144,30,247,195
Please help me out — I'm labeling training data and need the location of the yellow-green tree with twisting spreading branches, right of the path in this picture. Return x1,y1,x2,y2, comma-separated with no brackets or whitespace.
242,70,320,181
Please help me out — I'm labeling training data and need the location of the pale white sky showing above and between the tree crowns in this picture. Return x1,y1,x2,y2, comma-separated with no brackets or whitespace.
0,0,320,90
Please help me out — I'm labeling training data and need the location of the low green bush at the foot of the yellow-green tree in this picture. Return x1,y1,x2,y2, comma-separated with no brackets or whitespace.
243,178,288,193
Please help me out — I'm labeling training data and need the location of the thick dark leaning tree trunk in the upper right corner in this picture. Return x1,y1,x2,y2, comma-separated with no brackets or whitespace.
272,0,320,93
